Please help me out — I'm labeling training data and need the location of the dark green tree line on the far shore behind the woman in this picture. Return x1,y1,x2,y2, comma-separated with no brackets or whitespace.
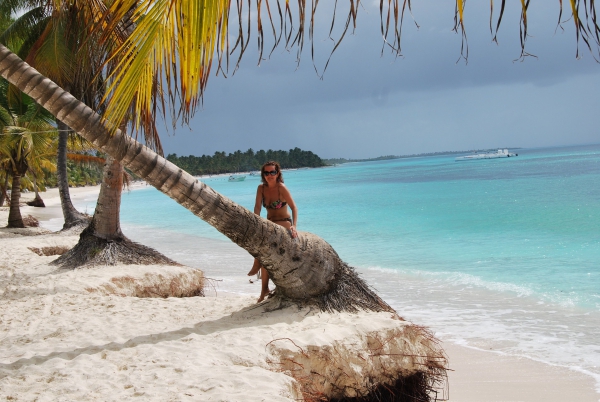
167,147,325,176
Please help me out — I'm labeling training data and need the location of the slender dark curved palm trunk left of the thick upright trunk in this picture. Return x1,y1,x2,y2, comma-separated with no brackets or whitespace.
56,120,89,230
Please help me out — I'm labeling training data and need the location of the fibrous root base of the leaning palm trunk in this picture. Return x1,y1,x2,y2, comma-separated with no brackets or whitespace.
265,263,397,314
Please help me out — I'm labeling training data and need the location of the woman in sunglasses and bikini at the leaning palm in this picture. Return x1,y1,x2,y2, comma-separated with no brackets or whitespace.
248,161,298,303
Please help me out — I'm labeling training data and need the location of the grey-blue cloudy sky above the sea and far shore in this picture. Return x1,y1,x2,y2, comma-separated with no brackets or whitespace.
160,0,600,158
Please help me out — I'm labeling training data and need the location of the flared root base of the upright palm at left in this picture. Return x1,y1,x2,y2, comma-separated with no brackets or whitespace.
50,227,181,269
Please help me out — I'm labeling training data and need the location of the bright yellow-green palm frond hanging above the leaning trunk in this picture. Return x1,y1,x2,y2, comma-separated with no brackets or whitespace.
105,0,228,127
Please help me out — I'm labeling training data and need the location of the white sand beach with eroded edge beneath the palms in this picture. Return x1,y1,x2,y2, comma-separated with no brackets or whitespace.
0,186,600,401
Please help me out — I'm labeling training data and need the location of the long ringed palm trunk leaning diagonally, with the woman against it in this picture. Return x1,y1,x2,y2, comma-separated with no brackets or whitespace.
0,41,393,311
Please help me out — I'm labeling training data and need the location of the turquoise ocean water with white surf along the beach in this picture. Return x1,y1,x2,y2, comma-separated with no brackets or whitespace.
70,145,600,392
